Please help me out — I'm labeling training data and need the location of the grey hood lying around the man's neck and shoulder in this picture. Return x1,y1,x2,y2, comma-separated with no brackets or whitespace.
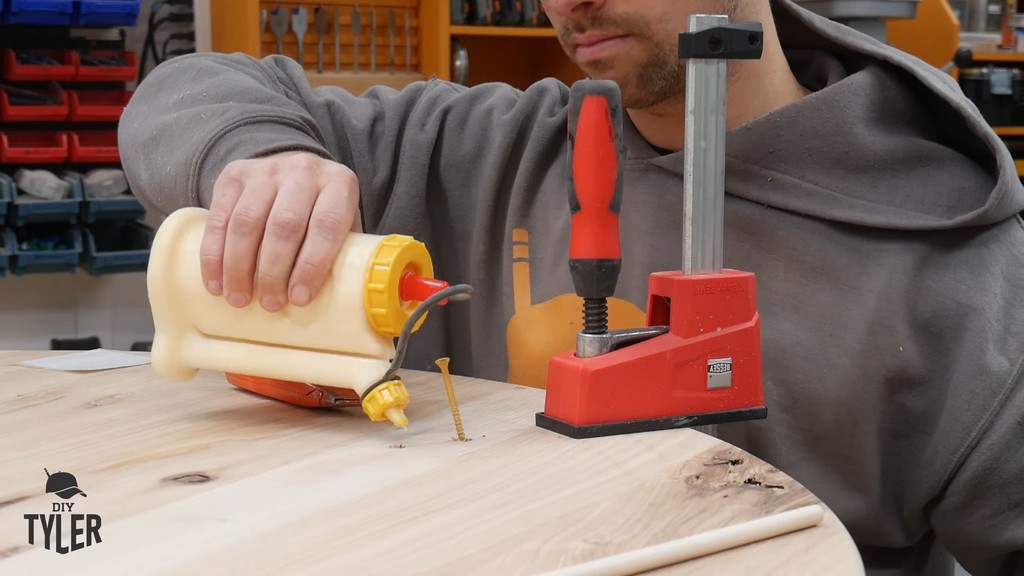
654,0,1024,230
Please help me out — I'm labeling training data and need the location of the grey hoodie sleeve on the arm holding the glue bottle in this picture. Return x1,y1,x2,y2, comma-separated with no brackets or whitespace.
119,49,568,234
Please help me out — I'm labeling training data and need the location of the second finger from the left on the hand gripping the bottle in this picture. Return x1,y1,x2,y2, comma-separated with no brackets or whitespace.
224,177,276,307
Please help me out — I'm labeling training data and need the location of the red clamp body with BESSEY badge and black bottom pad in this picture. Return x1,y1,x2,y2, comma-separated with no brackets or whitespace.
537,270,766,438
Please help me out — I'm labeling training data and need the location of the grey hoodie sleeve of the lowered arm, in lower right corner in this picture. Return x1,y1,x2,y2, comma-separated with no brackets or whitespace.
932,362,1024,576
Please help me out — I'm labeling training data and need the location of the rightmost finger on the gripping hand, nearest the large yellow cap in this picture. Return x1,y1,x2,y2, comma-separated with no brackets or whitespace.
288,172,358,306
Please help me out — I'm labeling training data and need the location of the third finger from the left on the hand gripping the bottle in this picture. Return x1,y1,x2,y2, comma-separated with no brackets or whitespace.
256,176,318,312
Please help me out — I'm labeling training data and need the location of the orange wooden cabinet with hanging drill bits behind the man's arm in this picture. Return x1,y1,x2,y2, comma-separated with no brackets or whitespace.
210,0,583,93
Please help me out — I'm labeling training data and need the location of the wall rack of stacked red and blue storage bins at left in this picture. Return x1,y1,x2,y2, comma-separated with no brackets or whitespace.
0,0,153,276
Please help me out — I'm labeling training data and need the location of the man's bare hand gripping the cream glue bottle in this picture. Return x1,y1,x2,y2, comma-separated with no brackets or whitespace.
200,147,361,312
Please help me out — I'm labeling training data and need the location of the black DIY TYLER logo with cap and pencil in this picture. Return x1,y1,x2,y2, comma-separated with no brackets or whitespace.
25,468,102,554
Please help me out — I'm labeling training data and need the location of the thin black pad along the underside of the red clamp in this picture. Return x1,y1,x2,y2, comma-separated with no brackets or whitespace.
537,406,768,440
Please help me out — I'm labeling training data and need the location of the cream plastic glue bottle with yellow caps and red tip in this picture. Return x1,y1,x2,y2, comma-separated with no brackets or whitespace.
146,208,447,427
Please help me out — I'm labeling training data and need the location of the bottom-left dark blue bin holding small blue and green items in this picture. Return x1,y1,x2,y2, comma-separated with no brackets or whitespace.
11,224,82,276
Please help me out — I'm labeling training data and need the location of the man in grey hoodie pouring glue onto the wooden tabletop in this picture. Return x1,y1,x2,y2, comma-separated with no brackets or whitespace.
121,0,1024,574
